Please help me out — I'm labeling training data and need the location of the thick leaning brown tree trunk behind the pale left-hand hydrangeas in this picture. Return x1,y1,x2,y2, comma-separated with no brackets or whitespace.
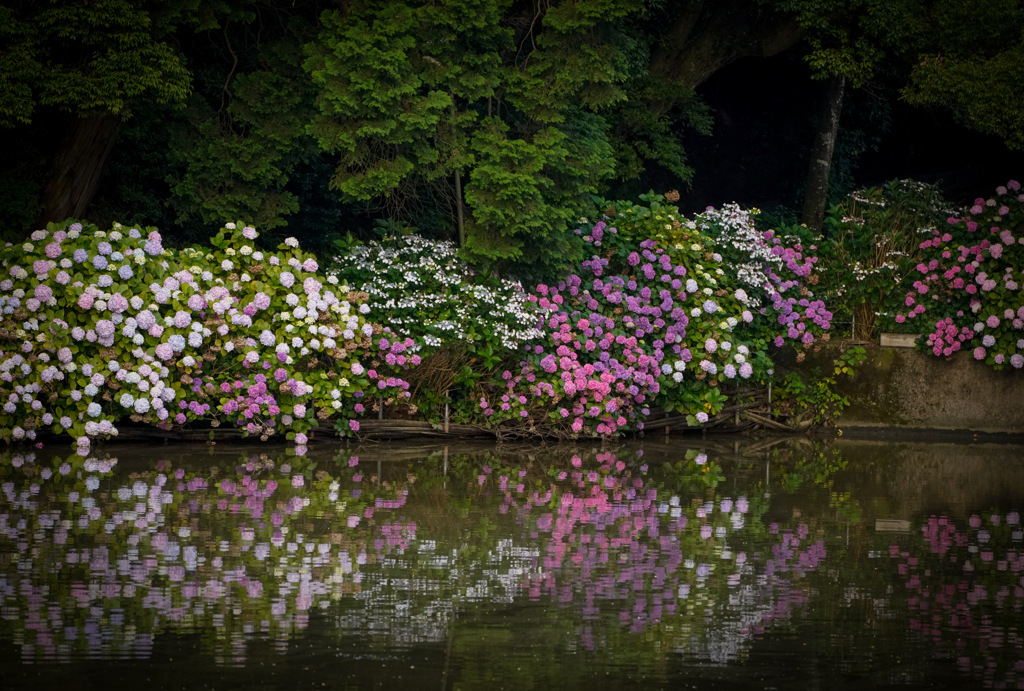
37,114,121,225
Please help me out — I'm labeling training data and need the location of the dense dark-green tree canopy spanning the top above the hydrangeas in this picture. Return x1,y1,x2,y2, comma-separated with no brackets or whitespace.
0,0,1024,271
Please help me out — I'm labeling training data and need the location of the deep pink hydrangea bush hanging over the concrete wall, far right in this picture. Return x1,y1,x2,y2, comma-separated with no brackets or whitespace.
896,180,1024,370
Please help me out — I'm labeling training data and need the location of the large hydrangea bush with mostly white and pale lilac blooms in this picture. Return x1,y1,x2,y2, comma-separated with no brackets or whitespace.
0,222,408,446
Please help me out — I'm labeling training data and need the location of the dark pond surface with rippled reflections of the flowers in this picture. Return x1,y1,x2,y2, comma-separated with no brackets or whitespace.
0,439,1024,689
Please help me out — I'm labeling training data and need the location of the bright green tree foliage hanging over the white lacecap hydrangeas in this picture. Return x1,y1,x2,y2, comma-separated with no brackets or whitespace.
305,1,633,274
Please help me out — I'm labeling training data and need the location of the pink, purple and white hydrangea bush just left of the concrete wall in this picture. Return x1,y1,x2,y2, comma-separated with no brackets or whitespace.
468,191,831,435
